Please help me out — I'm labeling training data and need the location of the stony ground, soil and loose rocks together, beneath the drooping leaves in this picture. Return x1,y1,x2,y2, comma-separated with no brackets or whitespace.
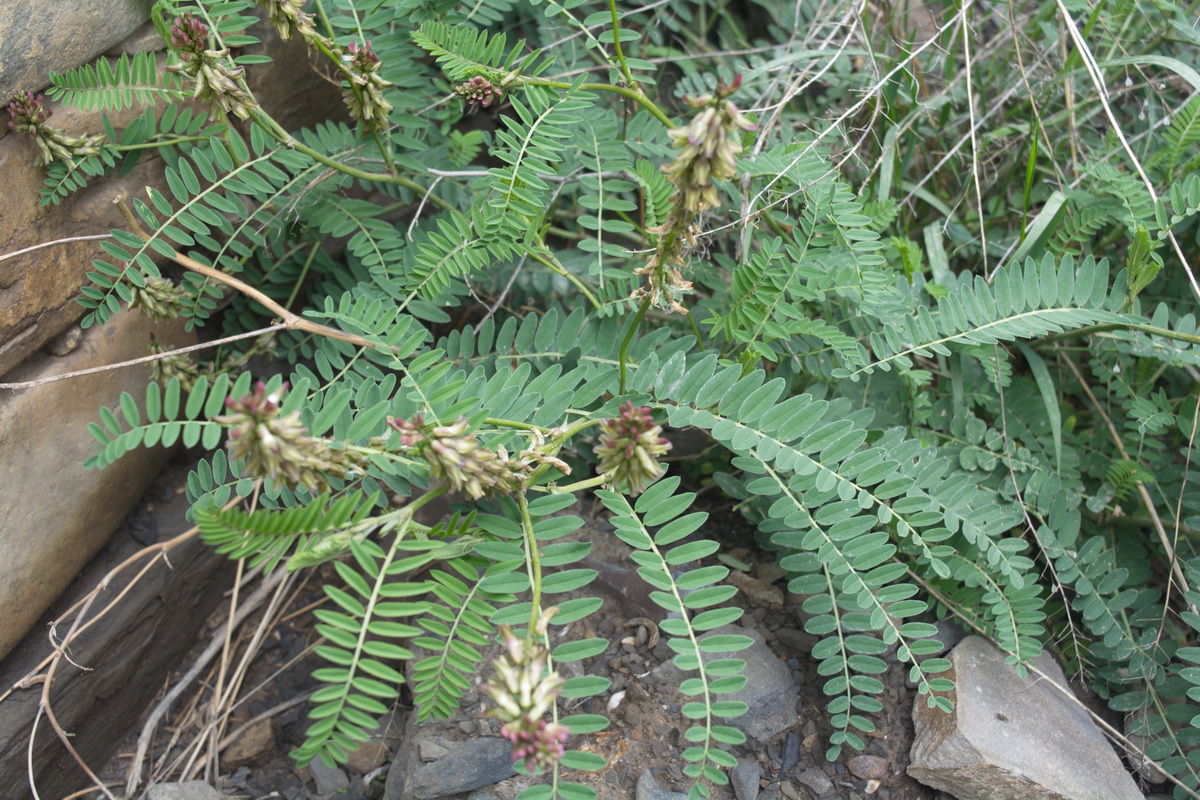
93,470,1161,800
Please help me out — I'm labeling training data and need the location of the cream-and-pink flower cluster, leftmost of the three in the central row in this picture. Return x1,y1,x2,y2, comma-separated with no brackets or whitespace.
214,381,364,494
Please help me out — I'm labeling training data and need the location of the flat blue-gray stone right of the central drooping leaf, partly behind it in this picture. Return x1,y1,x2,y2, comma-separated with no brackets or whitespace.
655,625,800,742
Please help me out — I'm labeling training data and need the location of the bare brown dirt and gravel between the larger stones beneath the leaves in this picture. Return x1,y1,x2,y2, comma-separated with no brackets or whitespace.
96,482,964,800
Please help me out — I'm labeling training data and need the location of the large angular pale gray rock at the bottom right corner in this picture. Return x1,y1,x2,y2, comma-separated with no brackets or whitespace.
908,636,1142,800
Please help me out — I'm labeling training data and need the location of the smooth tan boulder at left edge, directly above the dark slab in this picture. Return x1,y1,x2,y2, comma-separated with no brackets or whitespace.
0,309,194,657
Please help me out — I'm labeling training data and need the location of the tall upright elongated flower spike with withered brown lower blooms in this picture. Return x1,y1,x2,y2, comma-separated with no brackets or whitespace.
634,76,756,313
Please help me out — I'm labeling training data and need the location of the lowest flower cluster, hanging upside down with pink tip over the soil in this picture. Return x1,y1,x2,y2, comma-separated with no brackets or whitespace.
484,608,568,772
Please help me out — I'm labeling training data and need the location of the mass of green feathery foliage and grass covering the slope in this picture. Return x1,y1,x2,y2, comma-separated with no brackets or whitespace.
43,0,1200,800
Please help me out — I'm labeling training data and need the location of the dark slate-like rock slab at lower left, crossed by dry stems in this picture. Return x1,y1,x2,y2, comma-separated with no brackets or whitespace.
0,482,233,800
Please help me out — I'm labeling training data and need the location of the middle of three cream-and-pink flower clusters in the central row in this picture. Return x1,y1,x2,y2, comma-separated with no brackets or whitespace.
388,414,524,500
